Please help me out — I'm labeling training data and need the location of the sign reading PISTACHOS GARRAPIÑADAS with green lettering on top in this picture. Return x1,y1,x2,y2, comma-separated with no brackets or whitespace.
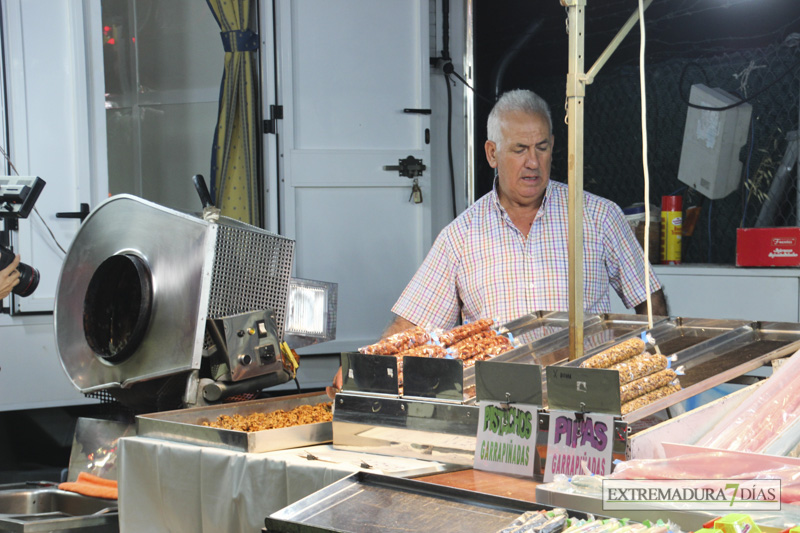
473,400,538,478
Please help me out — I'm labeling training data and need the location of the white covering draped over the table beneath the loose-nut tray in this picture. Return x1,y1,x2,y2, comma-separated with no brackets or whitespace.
119,437,442,533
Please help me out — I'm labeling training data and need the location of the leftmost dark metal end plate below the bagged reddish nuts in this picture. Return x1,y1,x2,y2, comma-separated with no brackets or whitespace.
342,352,398,394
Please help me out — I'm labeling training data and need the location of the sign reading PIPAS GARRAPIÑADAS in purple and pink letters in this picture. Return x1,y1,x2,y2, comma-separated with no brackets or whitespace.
544,408,614,483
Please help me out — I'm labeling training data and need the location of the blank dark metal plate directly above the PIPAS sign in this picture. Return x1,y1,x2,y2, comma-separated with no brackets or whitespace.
545,366,622,415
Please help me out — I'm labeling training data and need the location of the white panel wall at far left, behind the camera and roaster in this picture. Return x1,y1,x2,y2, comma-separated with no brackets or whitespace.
0,0,107,411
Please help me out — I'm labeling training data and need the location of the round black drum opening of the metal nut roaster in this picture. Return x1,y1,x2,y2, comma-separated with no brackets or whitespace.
83,254,153,363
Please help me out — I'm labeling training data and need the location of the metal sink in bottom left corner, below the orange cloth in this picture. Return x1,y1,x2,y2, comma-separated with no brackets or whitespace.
0,482,119,533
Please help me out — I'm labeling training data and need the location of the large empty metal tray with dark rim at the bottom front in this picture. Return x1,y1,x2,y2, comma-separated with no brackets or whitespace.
264,472,587,533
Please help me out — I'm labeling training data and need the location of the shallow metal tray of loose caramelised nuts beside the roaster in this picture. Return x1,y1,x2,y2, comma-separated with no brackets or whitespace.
136,392,333,453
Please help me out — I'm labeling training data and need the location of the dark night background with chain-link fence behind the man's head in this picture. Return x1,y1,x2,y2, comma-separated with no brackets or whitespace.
474,0,800,264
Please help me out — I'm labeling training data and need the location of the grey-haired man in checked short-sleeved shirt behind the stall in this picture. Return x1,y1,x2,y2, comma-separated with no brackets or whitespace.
324,90,667,394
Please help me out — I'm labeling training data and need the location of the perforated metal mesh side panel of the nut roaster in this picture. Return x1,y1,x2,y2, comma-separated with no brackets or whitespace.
208,218,294,338
